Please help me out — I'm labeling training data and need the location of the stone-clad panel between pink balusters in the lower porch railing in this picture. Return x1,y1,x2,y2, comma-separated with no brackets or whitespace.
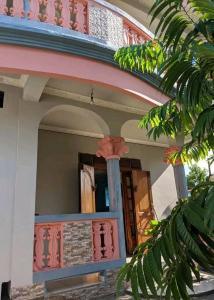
63,221,93,268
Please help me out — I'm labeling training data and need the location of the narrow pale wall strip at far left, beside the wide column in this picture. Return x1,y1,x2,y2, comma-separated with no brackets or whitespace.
0,89,18,283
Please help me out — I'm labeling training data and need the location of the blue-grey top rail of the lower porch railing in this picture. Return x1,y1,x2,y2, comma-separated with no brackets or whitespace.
35,212,119,224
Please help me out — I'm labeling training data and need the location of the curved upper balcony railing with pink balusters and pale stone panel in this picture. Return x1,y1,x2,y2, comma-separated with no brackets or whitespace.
0,0,150,47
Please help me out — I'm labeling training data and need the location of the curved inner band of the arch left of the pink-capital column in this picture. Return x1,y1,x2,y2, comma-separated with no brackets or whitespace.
40,104,110,136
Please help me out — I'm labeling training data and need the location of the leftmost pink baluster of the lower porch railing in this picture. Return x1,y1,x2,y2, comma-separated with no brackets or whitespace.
33,225,45,272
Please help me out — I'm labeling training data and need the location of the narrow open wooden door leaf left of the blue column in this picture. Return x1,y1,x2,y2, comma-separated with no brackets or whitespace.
80,165,96,214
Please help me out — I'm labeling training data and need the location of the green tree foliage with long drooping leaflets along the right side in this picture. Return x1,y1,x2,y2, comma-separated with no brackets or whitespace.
115,0,214,299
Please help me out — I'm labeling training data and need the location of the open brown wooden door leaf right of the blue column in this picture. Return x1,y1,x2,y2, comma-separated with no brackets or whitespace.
132,170,154,244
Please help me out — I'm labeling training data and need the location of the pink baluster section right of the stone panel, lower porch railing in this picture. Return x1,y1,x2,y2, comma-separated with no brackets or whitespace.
92,220,119,261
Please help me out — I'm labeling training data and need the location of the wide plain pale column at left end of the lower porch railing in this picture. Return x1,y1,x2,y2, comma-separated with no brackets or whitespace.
11,101,41,287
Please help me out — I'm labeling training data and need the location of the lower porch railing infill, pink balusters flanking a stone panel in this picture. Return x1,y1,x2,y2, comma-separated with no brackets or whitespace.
33,219,119,272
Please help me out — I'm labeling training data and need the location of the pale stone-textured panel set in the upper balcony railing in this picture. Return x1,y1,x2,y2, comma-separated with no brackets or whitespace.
88,3,124,47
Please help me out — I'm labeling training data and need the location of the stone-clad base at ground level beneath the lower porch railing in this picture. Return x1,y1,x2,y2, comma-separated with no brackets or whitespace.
11,270,118,300
